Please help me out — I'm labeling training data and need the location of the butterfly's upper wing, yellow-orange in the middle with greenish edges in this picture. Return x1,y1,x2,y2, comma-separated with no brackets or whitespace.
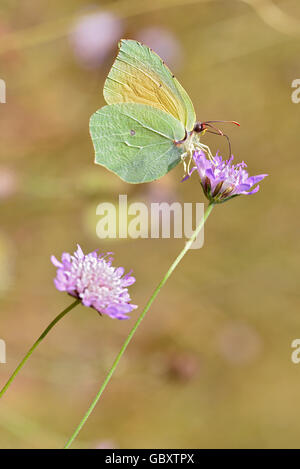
104,39,196,131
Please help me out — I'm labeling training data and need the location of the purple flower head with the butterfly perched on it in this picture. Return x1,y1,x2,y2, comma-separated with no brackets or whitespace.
184,151,268,203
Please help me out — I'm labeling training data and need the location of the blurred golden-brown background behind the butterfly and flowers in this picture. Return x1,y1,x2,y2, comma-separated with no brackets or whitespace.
0,0,300,448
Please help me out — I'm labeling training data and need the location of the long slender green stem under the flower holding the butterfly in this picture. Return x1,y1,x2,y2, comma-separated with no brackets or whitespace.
64,204,214,449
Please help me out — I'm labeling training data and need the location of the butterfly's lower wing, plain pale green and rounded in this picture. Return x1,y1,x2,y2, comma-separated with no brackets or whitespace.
90,103,185,183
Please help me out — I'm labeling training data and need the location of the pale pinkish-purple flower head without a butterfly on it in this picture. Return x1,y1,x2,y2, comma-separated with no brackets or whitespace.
51,245,137,319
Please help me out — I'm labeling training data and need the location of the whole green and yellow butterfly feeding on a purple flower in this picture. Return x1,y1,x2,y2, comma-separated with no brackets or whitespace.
90,39,238,183
